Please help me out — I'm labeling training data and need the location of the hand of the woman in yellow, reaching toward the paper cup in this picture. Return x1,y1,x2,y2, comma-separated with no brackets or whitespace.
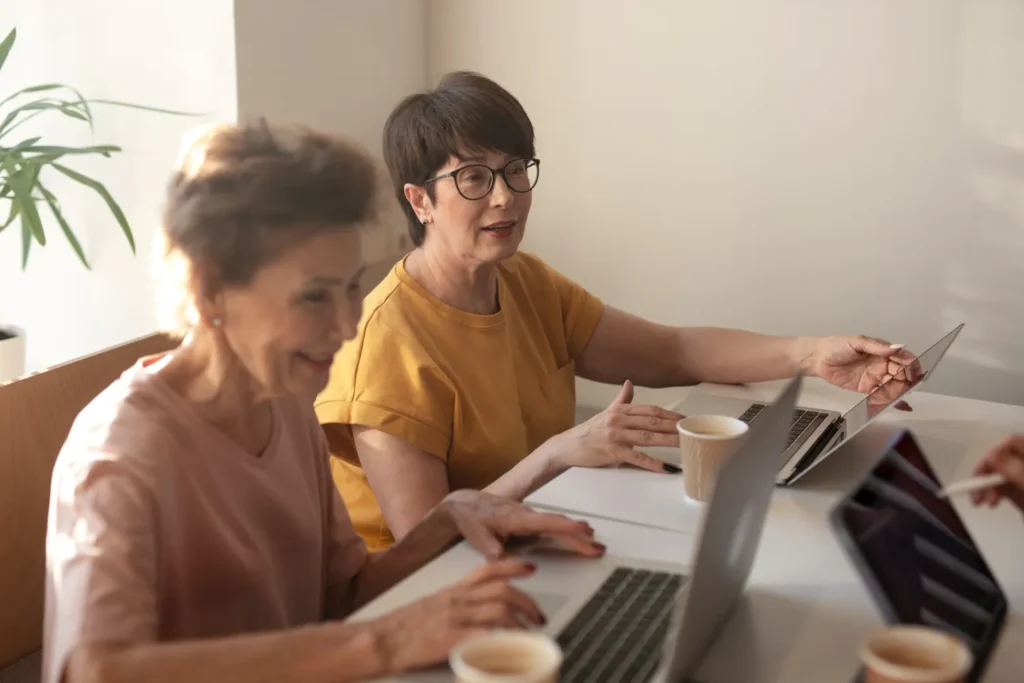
545,381,683,472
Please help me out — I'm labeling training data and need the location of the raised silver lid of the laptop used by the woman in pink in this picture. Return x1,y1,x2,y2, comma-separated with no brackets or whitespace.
654,375,803,682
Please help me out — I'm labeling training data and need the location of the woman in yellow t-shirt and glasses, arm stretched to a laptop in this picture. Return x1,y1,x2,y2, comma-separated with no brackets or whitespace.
316,73,912,549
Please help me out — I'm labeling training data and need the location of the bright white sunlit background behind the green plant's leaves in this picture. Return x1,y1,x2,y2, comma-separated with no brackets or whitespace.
0,0,236,370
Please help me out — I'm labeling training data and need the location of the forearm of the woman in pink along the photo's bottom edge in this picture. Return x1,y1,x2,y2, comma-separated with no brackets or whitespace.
63,623,396,683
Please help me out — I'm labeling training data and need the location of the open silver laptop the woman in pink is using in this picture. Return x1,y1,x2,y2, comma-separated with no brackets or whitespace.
487,376,802,683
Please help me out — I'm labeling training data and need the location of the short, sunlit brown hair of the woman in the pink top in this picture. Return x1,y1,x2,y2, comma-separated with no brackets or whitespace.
161,121,376,332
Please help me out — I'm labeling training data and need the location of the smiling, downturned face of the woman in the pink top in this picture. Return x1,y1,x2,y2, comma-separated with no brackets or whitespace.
215,227,362,395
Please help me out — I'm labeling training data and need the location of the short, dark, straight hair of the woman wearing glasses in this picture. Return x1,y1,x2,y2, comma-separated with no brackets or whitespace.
384,72,535,247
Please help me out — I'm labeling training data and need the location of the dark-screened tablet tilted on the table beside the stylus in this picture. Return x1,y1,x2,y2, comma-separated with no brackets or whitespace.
829,431,1007,681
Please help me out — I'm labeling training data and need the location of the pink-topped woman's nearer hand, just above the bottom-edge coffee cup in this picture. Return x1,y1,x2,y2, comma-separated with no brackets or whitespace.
371,559,546,673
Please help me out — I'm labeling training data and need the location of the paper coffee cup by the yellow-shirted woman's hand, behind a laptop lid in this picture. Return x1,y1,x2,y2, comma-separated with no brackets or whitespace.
676,415,749,502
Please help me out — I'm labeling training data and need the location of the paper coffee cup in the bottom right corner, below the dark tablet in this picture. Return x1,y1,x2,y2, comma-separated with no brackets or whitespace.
860,626,974,683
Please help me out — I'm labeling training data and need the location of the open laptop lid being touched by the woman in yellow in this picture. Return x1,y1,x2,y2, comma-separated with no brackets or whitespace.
786,323,964,483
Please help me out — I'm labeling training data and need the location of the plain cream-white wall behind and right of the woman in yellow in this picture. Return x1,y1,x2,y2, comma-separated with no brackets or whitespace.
429,0,1024,403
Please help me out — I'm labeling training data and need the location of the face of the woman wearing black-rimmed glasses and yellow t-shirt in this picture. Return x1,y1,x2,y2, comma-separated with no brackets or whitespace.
406,152,532,263
